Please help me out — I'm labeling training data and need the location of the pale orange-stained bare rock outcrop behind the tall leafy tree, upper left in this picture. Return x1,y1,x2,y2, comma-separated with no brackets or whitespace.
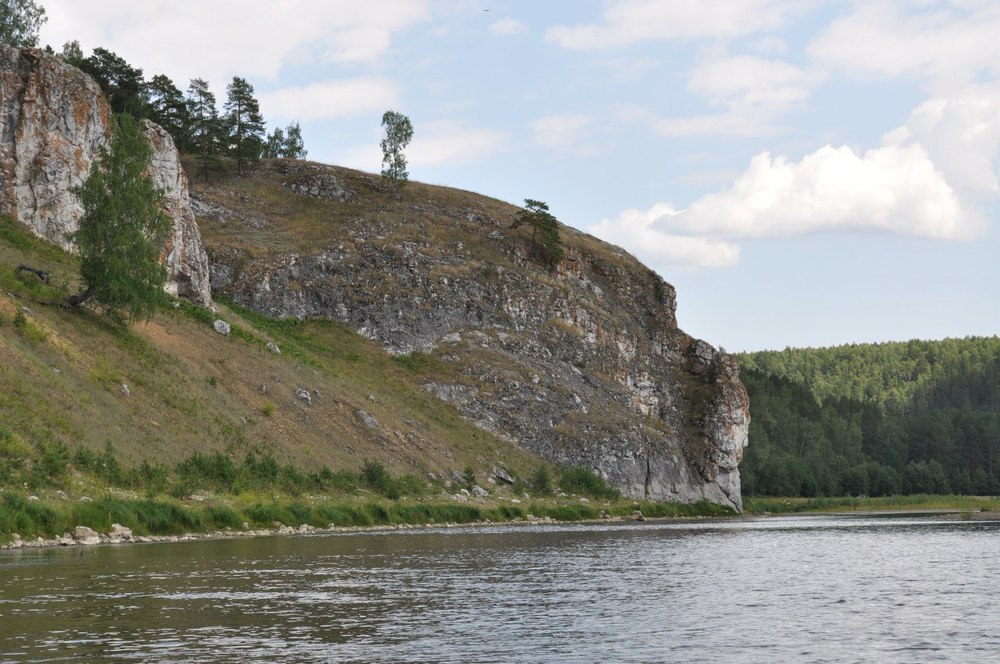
0,44,211,305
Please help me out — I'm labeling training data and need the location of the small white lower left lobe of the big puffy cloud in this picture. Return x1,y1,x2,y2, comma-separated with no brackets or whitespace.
587,203,740,271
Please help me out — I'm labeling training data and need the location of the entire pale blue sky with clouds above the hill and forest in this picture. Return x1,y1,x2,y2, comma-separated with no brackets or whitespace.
41,0,1000,350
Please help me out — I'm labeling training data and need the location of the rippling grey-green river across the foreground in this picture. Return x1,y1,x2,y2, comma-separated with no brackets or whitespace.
0,516,1000,664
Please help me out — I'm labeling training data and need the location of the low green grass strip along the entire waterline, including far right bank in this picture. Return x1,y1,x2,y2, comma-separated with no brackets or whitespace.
0,488,1000,550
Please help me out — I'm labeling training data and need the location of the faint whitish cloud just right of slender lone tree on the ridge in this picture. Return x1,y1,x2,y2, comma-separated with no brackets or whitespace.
406,122,510,166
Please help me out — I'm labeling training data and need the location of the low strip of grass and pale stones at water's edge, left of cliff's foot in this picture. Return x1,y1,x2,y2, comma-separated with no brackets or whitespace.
0,493,734,549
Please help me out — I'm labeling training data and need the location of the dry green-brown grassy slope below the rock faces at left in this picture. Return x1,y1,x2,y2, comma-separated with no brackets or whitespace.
0,215,537,486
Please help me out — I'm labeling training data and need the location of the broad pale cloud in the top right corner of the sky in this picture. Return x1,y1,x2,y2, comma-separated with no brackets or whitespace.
808,0,1000,93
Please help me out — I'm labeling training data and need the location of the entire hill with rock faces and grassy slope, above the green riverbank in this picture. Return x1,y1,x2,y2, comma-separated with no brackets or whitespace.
0,49,749,509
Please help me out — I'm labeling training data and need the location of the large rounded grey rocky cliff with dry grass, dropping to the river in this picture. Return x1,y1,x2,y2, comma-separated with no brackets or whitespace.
193,161,749,509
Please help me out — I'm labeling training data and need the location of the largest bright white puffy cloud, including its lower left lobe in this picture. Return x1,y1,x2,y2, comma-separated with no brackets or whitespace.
589,135,984,267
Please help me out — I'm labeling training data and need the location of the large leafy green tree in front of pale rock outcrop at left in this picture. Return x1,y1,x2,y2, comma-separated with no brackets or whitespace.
69,114,170,323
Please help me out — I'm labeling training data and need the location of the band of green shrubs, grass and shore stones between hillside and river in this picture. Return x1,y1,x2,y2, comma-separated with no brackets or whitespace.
0,444,734,548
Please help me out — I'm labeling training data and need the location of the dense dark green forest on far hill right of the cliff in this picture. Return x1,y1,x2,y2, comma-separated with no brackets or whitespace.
740,337,1000,496
